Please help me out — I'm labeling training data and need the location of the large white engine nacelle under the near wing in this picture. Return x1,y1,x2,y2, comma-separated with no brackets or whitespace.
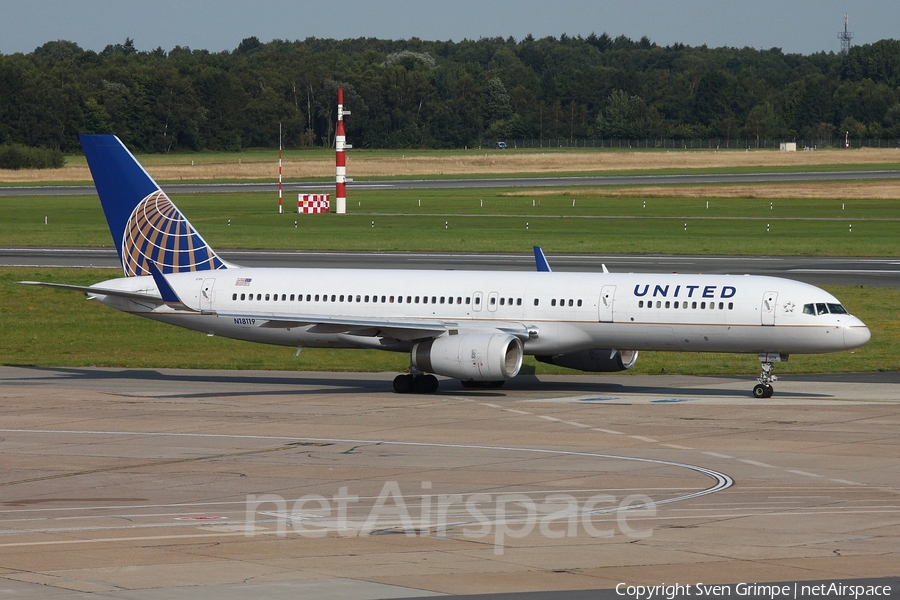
410,333,524,381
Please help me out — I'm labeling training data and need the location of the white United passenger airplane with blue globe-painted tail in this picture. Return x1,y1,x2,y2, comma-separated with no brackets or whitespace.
22,135,870,398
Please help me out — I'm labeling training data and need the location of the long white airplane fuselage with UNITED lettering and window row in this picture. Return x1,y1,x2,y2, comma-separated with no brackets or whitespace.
91,268,870,355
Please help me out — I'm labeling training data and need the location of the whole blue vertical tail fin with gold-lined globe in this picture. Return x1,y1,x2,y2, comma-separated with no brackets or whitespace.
81,135,226,277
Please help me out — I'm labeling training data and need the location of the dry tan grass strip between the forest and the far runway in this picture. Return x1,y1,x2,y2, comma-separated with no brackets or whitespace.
0,148,900,184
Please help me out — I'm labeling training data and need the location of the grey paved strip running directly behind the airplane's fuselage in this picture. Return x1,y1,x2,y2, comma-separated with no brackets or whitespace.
0,247,900,288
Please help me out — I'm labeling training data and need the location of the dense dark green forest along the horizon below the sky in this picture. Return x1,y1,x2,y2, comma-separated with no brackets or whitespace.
0,34,900,152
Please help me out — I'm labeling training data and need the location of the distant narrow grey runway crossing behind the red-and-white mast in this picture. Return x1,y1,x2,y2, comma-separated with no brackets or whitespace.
0,169,900,197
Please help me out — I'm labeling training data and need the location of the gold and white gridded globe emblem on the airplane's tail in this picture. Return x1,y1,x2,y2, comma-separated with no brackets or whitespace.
122,189,226,277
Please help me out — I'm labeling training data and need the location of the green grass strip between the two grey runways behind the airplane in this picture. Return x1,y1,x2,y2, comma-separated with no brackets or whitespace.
0,182,900,256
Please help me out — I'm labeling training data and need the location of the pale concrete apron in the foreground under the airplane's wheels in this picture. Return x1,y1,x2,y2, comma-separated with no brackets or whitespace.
0,367,900,600
